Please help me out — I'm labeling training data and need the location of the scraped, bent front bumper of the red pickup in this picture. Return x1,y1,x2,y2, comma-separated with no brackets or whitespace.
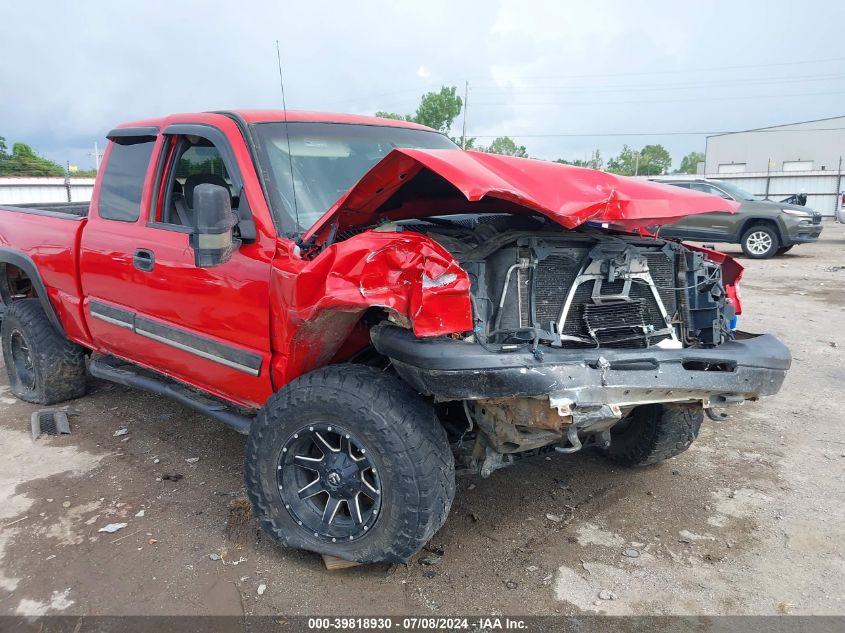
372,324,792,407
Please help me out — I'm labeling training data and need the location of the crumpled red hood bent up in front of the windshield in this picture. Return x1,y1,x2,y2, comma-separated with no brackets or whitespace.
304,149,739,243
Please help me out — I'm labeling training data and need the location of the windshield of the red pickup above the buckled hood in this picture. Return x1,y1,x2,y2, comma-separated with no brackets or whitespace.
252,121,457,233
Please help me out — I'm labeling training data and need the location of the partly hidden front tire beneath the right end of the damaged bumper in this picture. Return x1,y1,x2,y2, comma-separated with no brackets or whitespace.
603,404,704,466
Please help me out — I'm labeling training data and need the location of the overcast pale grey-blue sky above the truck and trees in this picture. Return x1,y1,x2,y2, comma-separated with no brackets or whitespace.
0,0,845,168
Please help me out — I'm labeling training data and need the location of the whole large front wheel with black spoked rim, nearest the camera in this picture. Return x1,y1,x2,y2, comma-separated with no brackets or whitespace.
245,365,455,562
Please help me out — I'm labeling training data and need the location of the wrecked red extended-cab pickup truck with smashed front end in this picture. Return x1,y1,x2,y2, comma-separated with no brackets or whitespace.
0,111,791,562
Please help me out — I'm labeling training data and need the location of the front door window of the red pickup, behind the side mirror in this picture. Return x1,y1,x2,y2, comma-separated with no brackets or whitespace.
157,136,237,227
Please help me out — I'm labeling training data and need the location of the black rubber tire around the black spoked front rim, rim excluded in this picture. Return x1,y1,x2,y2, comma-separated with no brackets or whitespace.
245,364,455,563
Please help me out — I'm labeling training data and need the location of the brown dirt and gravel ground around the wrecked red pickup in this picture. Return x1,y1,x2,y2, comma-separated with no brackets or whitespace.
0,223,845,615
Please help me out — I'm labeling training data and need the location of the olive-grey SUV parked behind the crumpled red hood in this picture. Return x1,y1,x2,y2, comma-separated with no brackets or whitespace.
654,178,822,259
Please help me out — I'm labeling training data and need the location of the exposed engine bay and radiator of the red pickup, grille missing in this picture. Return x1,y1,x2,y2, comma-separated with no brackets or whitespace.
396,214,734,355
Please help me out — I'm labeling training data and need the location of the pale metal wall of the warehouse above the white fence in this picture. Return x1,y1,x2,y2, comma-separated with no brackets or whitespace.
705,117,845,176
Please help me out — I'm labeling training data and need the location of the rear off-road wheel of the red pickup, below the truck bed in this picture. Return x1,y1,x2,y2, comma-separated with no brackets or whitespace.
0,299,87,404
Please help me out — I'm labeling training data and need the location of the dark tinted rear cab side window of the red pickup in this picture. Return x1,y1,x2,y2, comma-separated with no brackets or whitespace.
99,140,155,222
